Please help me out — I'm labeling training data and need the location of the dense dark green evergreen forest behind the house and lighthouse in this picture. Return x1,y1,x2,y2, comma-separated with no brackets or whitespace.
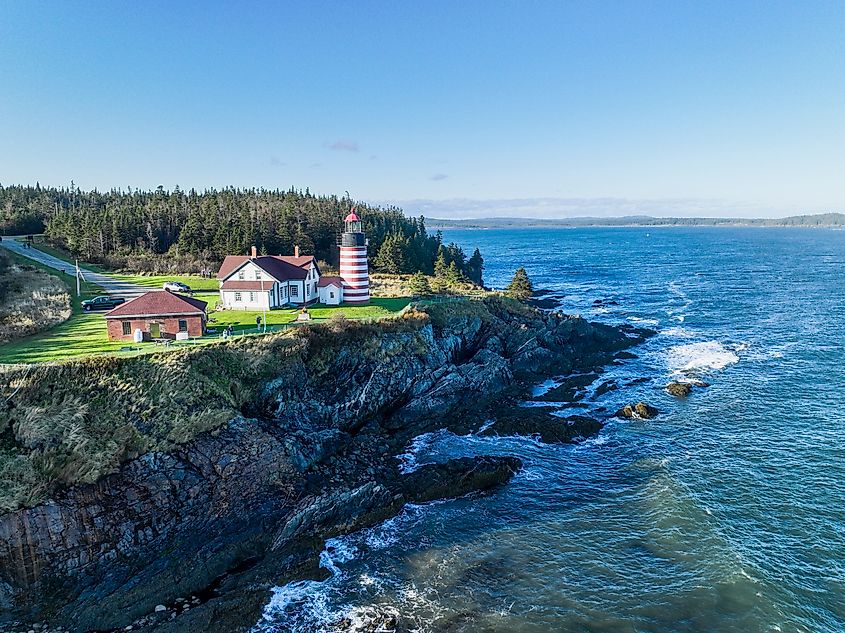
0,183,483,284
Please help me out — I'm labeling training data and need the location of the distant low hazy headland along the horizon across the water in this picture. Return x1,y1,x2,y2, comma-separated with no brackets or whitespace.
427,213,845,229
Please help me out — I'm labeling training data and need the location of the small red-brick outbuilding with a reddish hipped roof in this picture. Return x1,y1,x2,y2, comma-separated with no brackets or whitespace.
105,290,207,341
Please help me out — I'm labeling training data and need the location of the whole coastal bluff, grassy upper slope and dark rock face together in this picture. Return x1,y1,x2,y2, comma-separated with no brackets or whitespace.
0,297,649,631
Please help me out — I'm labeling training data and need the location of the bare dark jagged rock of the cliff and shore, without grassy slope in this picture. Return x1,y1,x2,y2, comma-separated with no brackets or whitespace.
0,299,650,632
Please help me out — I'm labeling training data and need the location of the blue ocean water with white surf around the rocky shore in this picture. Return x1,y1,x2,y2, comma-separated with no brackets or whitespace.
255,228,845,633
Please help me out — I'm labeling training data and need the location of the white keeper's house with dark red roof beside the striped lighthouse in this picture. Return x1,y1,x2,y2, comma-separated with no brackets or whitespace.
217,246,328,310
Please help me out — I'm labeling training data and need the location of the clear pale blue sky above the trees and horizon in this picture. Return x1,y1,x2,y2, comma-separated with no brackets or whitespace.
0,0,845,217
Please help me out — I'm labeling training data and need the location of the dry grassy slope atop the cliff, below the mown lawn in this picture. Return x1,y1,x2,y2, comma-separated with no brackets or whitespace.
0,311,426,512
